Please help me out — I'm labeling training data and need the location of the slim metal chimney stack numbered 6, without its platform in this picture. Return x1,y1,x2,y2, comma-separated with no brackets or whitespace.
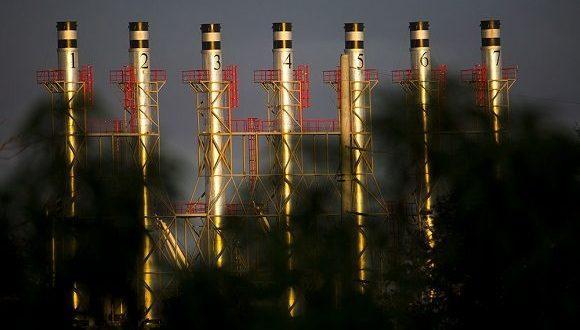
409,21,435,248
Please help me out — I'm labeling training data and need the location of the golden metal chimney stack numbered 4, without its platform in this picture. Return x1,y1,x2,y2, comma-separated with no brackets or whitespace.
272,22,299,317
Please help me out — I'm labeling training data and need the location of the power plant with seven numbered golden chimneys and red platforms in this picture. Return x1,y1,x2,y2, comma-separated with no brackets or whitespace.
36,19,517,326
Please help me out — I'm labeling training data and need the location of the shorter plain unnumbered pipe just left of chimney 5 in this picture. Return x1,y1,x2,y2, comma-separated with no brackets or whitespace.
338,54,352,217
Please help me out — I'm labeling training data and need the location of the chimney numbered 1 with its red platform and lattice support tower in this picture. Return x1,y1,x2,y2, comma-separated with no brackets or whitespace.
36,21,93,321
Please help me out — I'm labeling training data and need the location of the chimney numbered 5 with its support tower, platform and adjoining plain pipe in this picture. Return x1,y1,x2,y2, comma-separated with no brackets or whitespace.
323,23,392,293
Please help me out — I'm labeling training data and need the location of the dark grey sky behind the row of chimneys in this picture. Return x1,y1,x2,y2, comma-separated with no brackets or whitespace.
0,0,580,196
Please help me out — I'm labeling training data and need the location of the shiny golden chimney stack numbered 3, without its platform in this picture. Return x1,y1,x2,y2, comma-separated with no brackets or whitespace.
201,23,229,268
